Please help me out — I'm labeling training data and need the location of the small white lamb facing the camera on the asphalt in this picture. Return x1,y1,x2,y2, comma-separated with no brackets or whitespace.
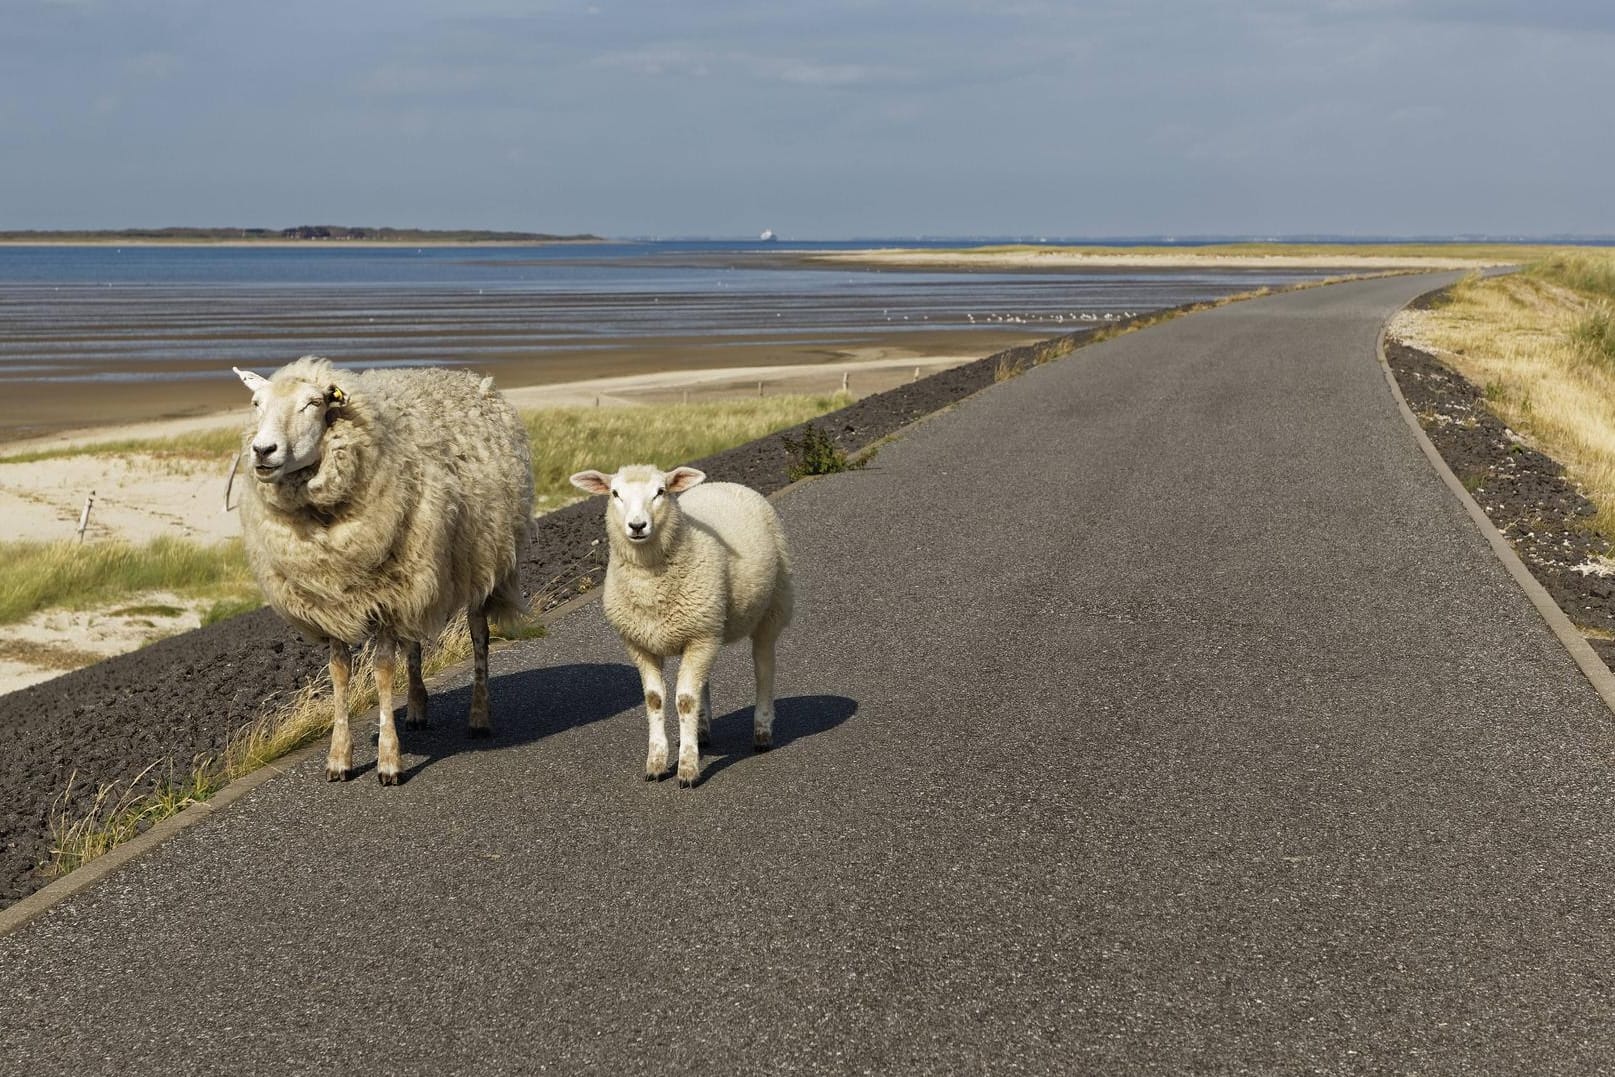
572,465,793,788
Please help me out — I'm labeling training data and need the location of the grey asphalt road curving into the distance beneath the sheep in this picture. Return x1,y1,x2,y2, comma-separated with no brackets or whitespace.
0,278,1615,1074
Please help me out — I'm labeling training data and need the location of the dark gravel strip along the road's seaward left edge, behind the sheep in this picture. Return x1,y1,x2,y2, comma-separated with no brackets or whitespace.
0,322,1160,907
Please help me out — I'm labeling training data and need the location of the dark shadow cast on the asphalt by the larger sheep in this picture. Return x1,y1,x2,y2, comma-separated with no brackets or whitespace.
392,662,642,782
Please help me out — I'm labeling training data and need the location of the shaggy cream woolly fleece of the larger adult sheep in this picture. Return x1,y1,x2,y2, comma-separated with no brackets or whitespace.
241,357,533,643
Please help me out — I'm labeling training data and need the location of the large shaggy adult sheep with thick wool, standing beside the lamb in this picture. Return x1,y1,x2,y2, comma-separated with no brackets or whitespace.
236,355,533,785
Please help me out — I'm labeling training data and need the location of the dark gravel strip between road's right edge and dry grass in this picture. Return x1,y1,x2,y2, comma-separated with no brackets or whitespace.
1386,341,1615,668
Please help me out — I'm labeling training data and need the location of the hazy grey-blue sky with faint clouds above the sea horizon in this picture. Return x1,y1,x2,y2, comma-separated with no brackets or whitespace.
0,0,1615,239
